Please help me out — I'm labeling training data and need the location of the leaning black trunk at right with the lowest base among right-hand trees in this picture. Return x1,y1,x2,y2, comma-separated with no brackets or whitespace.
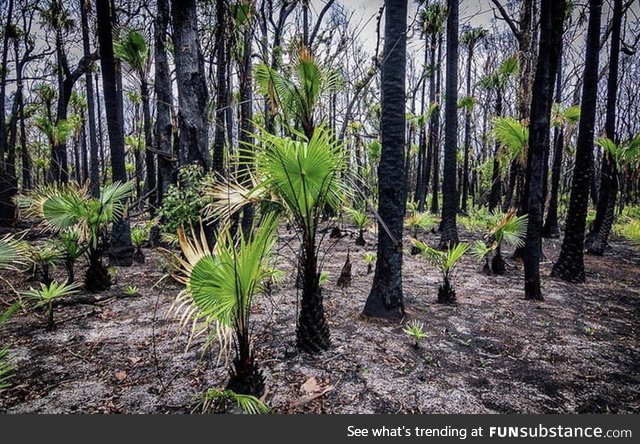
523,0,566,300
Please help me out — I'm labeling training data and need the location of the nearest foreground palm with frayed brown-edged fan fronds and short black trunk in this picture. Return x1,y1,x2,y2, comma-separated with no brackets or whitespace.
171,215,278,396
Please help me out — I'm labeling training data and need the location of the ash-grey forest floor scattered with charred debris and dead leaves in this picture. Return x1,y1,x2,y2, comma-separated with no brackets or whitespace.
0,224,640,413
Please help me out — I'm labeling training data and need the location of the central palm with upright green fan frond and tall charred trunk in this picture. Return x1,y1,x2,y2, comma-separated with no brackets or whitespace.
210,126,347,353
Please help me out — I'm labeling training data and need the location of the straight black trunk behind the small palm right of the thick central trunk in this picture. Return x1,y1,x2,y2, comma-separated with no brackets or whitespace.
440,0,459,248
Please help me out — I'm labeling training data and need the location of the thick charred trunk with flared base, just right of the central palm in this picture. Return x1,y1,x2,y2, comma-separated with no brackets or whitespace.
363,0,407,318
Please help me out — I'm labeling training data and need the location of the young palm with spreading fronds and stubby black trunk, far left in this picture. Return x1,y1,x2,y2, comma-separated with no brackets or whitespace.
19,182,135,292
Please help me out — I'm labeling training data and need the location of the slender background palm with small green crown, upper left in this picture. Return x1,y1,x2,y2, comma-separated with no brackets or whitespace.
113,30,156,208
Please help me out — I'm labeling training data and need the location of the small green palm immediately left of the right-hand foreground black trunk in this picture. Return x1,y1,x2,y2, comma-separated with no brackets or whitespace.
471,210,527,275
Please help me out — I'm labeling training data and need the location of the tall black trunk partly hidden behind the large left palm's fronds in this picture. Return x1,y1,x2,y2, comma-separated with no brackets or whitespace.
96,0,134,266
